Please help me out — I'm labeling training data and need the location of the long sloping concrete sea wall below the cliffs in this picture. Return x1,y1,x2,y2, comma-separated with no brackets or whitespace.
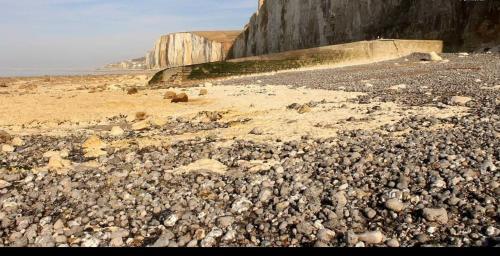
149,40,443,86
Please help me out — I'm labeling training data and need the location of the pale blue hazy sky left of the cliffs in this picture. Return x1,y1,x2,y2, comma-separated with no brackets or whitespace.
0,0,258,75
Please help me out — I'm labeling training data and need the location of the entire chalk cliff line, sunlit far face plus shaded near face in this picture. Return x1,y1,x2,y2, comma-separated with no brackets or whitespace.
107,0,500,69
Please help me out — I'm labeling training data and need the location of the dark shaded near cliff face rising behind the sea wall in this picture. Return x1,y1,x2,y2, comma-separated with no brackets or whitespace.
230,0,500,58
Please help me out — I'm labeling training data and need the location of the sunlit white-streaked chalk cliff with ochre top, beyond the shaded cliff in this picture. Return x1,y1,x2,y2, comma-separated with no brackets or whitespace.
146,31,241,69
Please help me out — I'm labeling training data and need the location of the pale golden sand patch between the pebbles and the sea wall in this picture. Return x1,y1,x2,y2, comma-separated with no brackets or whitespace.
0,75,467,144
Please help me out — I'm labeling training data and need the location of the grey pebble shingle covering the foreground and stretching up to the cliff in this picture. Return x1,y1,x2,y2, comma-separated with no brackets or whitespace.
0,54,500,247
